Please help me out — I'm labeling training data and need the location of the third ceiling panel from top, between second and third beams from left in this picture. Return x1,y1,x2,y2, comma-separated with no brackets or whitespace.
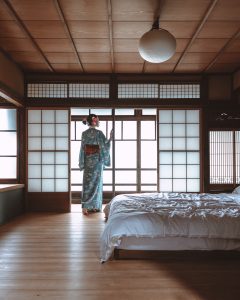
74,39,110,53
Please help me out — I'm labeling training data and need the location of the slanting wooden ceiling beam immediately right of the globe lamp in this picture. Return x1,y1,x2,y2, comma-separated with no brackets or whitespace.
172,0,219,73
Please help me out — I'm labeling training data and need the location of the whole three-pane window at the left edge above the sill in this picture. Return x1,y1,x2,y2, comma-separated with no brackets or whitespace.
0,109,17,179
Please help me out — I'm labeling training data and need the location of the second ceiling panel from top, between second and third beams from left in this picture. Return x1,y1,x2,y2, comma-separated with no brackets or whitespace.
68,21,109,39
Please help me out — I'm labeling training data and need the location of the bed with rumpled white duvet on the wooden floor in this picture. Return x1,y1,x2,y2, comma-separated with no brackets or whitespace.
100,193,240,262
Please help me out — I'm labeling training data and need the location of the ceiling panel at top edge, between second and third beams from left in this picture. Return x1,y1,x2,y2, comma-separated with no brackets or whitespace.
59,0,108,21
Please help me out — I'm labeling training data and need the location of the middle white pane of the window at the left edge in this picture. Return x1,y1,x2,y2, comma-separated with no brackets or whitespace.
0,131,17,156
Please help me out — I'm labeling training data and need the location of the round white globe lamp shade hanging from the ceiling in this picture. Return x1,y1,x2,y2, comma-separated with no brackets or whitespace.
138,28,176,63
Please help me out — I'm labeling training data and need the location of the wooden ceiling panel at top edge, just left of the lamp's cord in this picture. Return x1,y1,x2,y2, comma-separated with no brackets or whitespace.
111,0,153,22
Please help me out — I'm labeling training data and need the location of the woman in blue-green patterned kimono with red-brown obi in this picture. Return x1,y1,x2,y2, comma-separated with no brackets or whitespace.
79,114,112,215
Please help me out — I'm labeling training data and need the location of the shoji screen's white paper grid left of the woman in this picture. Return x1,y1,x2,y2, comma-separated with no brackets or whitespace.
28,110,69,192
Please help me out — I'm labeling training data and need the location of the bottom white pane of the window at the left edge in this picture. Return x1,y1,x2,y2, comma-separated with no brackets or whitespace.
0,157,17,179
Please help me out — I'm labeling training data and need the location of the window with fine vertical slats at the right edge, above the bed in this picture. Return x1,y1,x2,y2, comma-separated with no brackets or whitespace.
209,130,240,184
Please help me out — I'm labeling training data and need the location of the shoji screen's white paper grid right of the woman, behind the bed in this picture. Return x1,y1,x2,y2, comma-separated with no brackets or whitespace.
158,110,200,192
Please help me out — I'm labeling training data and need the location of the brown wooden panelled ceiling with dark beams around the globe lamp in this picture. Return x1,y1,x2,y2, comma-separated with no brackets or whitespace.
0,0,240,74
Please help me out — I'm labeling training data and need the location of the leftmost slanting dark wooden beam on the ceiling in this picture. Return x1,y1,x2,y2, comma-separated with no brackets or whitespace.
3,0,54,72
